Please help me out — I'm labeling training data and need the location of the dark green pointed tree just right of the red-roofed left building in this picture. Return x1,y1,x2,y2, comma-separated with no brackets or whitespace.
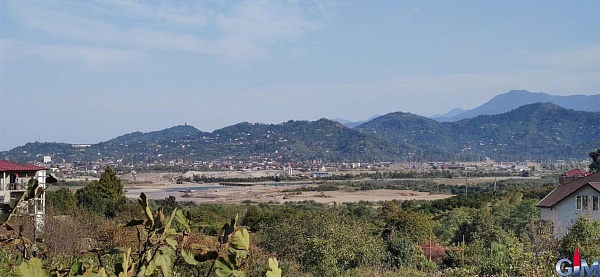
75,166,126,218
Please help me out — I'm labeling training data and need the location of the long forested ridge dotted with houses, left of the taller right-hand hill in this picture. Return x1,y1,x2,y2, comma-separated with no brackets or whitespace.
0,119,401,163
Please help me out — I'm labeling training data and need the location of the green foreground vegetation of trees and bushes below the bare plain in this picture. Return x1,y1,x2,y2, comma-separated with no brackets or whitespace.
0,165,600,276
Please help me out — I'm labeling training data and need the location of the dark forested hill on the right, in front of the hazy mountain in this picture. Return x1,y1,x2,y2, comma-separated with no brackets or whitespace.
356,103,600,161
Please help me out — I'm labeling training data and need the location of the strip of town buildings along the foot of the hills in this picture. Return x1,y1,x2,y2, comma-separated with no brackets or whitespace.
14,149,590,179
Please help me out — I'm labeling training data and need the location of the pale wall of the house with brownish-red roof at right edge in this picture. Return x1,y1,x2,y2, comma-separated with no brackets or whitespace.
540,185,600,237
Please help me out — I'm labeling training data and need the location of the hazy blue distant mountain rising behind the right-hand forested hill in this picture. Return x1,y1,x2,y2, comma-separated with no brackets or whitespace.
431,90,600,122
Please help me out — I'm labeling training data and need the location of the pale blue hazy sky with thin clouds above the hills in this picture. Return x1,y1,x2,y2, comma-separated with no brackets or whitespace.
0,0,600,150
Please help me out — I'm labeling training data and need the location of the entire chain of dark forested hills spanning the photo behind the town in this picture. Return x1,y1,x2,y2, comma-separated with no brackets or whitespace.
0,103,600,163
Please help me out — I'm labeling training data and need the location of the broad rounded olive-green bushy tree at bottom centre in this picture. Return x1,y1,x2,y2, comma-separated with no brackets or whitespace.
259,209,385,276
